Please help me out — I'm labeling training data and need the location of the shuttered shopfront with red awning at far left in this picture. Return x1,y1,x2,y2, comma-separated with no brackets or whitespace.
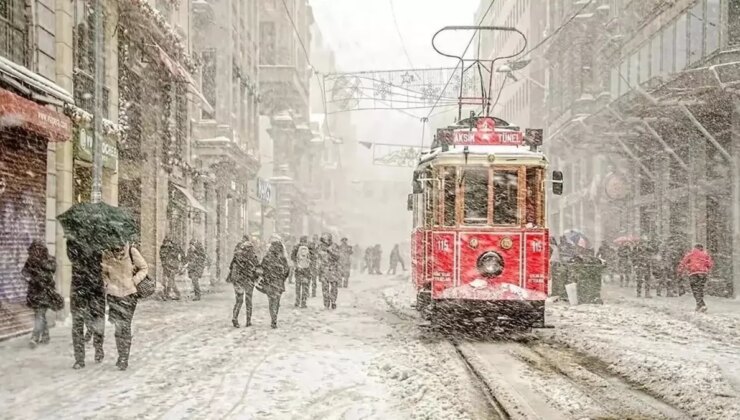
0,89,71,339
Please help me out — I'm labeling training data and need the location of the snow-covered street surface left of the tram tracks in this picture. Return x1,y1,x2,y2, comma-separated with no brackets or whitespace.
0,276,498,419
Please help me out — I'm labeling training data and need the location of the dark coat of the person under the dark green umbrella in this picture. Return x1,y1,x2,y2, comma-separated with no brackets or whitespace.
67,238,105,310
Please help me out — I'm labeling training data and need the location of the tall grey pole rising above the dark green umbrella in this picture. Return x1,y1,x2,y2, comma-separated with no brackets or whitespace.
91,0,107,203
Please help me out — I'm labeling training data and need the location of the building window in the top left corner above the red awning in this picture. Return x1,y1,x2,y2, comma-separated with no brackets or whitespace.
0,0,28,66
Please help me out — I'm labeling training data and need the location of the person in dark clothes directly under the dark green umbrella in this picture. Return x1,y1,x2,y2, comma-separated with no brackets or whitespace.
67,236,105,369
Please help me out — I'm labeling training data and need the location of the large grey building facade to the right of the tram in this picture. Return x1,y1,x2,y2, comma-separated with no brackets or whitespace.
545,0,740,295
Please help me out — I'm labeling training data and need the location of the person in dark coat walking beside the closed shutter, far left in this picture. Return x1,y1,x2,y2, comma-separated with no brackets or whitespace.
21,240,58,348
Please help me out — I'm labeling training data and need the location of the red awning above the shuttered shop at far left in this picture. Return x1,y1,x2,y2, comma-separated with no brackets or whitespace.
0,89,72,141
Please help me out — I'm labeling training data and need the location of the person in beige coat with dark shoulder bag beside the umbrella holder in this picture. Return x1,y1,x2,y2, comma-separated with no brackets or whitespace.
102,243,149,370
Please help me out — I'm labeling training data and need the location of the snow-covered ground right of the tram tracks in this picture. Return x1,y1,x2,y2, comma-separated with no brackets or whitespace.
540,285,740,419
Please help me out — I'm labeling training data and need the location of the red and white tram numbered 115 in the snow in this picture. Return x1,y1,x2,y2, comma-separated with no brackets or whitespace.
408,117,562,328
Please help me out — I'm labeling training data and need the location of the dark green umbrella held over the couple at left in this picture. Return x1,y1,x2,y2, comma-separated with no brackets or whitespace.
58,202,139,251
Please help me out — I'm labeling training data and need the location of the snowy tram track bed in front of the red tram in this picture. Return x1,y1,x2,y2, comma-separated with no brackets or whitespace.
386,288,688,420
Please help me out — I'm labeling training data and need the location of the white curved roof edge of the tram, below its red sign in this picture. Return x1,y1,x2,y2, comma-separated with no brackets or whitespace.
419,146,547,166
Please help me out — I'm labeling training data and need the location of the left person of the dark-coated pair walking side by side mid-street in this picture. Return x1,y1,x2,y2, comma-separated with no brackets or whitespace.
226,240,260,328
